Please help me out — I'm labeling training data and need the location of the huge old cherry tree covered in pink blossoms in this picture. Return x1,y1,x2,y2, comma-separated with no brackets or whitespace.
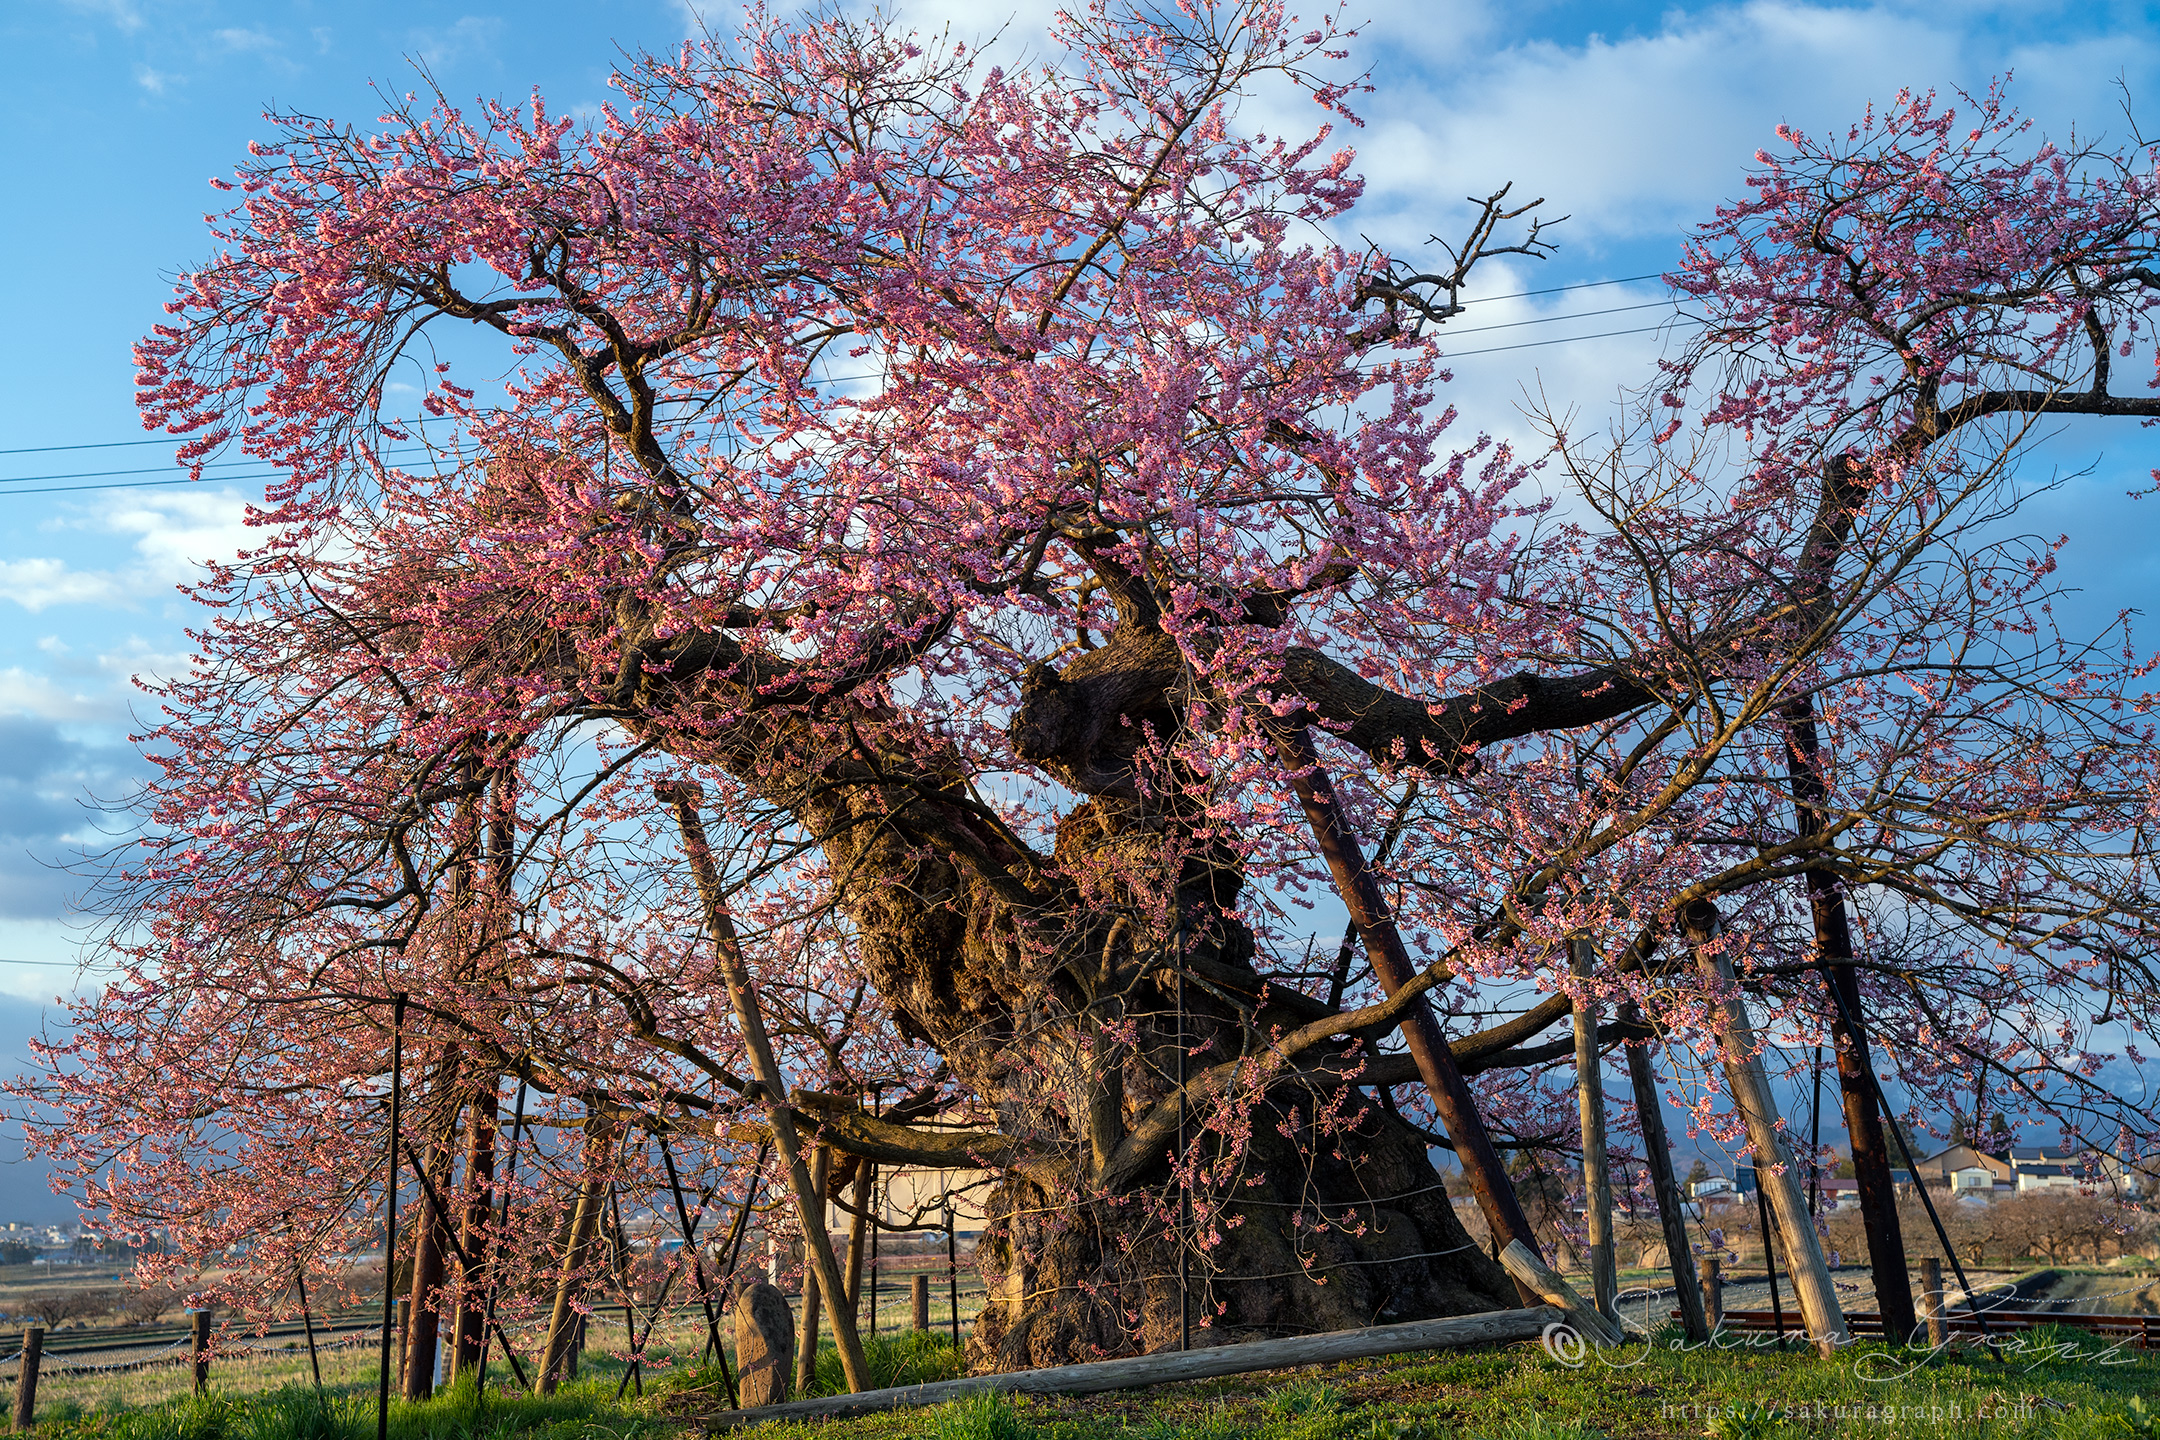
28,2,2160,1367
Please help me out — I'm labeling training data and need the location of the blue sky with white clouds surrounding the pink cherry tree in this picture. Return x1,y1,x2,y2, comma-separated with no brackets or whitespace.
0,0,2160,1220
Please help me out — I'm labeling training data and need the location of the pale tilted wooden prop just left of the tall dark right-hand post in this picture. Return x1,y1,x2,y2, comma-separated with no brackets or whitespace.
1680,900,1851,1358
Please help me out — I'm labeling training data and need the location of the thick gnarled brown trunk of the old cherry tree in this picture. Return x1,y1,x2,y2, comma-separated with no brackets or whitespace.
617,633,1598,1369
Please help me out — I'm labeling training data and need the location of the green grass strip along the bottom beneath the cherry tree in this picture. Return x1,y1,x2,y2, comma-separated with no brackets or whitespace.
21,1330,2160,1440
